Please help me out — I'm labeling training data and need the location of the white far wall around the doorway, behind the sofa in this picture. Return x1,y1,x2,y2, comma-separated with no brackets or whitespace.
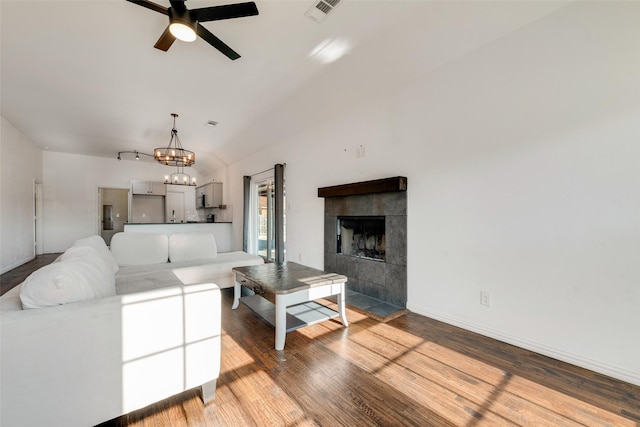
42,151,202,252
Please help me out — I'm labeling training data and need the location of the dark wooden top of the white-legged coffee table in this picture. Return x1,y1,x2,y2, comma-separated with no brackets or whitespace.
233,262,347,294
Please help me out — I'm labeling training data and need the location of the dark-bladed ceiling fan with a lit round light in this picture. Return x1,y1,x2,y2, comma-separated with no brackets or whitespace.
127,0,258,59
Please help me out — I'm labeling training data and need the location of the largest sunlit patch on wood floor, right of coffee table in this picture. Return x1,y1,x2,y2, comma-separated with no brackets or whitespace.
328,323,635,426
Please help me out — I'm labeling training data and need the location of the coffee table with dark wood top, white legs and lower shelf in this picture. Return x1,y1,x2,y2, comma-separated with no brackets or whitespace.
232,262,349,350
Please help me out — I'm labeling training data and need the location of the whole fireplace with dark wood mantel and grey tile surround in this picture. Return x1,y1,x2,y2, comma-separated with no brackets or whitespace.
318,177,407,308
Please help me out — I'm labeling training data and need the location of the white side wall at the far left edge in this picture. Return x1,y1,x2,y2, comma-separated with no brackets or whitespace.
0,117,42,274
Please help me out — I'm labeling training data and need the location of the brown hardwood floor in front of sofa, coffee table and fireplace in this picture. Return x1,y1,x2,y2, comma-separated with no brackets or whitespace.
2,260,640,427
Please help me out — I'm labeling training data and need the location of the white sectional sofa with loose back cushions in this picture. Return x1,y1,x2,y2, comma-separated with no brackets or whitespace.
0,232,263,426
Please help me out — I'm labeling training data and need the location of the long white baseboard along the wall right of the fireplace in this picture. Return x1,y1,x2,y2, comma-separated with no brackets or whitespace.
407,304,640,386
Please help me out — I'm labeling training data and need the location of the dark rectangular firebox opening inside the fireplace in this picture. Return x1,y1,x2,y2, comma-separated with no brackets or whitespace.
336,216,386,262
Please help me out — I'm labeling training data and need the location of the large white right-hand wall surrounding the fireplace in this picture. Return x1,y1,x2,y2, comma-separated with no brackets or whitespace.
218,2,640,385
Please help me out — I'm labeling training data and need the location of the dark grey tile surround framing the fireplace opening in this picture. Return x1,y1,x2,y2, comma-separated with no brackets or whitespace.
318,177,407,309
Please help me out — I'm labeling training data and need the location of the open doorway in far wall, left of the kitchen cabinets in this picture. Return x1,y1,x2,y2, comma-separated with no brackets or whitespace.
98,187,129,246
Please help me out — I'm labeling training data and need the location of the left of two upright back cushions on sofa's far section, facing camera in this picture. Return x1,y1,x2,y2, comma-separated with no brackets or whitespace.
111,232,169,267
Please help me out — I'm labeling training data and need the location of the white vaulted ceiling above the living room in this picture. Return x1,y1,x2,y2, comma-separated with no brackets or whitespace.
0,0,569,173
